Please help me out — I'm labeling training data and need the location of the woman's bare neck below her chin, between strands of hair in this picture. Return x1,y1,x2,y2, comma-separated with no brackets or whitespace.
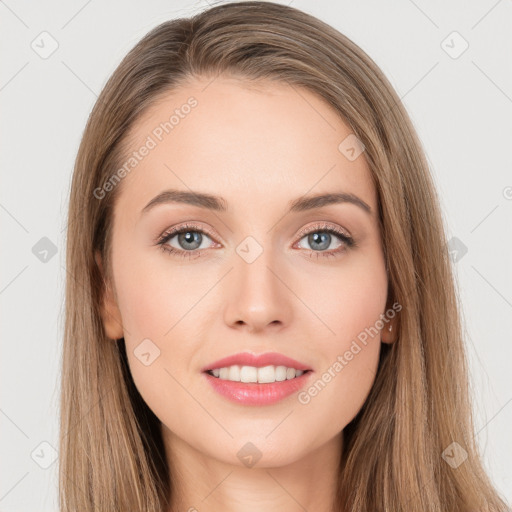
162,427,343,512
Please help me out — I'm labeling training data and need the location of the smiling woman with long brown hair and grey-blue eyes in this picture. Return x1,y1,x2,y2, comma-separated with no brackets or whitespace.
60,2,507,512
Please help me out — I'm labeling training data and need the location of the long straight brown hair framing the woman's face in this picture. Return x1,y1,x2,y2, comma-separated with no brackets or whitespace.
59,1,507,512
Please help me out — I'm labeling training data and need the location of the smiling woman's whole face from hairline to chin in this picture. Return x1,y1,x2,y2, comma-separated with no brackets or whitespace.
98,77,391,467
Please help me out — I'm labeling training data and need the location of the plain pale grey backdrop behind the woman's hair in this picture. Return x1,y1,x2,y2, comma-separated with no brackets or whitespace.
0,0,512,512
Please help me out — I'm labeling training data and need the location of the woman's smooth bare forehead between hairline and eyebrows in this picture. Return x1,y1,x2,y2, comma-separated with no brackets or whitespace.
113,77,376,218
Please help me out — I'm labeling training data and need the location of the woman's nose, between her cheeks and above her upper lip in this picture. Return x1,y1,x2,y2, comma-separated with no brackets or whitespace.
224,242,293,333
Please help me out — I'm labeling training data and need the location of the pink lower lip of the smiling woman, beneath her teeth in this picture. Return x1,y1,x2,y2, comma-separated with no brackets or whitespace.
204,371,313,405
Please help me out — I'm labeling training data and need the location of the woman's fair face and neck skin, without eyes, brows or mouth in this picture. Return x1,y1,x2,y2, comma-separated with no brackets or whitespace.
97,76,394,512
